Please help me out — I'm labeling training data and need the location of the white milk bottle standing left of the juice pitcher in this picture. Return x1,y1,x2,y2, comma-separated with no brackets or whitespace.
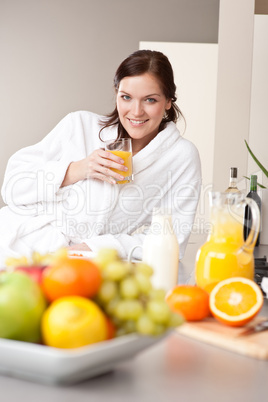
142,209,179,291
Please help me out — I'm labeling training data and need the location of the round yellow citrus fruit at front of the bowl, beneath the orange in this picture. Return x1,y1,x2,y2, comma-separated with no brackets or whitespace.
41,296,108,349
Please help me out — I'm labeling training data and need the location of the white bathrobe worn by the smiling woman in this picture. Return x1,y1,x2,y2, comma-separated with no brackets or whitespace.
0,111,201,266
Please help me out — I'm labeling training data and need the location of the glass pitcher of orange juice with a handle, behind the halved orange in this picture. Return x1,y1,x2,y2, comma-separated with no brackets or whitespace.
195,192,260,292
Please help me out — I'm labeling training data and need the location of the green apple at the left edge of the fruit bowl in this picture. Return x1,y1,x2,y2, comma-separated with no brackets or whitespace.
0,272,47,342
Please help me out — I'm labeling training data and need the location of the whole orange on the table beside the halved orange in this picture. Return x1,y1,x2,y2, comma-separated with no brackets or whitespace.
166,285,210,321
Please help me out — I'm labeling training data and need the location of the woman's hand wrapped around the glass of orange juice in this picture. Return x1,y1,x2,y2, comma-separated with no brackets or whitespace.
61,148,128,187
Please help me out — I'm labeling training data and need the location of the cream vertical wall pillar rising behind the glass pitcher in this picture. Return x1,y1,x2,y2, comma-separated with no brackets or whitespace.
213,0,255,190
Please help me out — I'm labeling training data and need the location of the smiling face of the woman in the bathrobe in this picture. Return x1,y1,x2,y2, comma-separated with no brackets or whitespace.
116,73,171,154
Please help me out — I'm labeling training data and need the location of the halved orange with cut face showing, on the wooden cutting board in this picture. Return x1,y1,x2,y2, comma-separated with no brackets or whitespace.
209,277,263,327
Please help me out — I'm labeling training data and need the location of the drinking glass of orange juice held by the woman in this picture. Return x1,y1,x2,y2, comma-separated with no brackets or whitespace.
105,138,133,184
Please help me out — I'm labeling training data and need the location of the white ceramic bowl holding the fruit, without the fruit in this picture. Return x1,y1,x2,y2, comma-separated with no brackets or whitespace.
0,331,170,384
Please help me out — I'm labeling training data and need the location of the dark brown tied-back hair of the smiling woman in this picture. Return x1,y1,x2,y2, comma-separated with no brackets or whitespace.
99,50,183,139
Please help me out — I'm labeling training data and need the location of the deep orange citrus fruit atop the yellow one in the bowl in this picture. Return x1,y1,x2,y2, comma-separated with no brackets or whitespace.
42,257,102,301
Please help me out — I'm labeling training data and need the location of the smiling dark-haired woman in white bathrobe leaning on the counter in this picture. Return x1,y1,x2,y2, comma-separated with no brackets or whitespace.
0,50,201,264
